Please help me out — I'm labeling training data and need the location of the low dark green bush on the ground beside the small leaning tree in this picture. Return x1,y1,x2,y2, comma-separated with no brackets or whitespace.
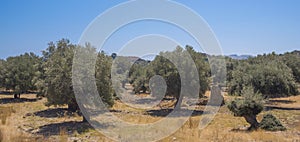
259,114,286,131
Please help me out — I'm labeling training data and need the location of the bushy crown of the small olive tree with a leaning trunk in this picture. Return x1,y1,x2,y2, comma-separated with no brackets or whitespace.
227,87,264,117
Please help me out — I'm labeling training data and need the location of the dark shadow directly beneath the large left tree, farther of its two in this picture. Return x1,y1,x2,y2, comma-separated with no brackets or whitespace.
31,108,75,118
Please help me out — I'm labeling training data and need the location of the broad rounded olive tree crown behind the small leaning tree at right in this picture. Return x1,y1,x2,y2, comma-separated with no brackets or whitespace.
228,54,297,97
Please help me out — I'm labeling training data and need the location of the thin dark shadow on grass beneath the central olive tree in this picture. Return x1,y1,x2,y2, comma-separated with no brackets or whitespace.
146,109,203,117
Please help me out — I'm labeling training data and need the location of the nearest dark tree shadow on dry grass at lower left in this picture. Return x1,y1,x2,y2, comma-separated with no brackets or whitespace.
31,121,93,137
